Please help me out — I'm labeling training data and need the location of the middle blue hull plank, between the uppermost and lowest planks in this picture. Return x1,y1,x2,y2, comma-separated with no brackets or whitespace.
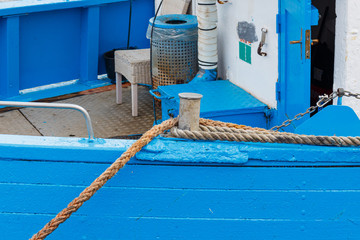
0,184,360,221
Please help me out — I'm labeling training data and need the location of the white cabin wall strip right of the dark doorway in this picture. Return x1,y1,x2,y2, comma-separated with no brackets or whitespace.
334,0,360,116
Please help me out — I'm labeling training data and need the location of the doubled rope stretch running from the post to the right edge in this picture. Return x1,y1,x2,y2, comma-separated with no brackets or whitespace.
171,119,360,147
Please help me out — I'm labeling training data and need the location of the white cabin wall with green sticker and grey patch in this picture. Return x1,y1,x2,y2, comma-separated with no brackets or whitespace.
218,0,278,108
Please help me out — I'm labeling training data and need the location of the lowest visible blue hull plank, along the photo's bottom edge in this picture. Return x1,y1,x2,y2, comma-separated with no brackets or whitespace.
0,214,360,240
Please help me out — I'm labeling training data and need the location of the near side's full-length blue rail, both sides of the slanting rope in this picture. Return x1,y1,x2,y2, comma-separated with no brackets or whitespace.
0,135,360,167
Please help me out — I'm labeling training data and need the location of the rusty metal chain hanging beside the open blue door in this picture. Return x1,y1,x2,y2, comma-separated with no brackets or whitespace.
270,88,360,132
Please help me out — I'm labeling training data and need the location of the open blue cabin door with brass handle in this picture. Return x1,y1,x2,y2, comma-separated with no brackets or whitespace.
274,0,319,131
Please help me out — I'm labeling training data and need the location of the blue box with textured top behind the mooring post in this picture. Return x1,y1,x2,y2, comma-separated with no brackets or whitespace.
159,80,268,128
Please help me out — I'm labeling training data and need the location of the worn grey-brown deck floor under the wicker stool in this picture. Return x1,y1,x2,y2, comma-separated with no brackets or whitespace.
0,86,158,138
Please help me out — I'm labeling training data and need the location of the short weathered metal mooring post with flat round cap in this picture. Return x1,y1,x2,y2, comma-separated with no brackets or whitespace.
179,93,203,131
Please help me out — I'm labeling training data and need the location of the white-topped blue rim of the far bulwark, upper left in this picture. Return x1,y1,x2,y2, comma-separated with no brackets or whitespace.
0,0,129,16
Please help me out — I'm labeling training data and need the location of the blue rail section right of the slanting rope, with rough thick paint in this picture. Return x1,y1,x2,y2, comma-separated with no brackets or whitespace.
136,138,360,166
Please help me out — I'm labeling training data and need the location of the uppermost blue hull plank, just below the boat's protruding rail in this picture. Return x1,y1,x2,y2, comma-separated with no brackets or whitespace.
0,160,360,191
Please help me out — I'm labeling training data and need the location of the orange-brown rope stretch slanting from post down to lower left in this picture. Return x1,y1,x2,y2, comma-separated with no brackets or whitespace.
31,119,178,240
